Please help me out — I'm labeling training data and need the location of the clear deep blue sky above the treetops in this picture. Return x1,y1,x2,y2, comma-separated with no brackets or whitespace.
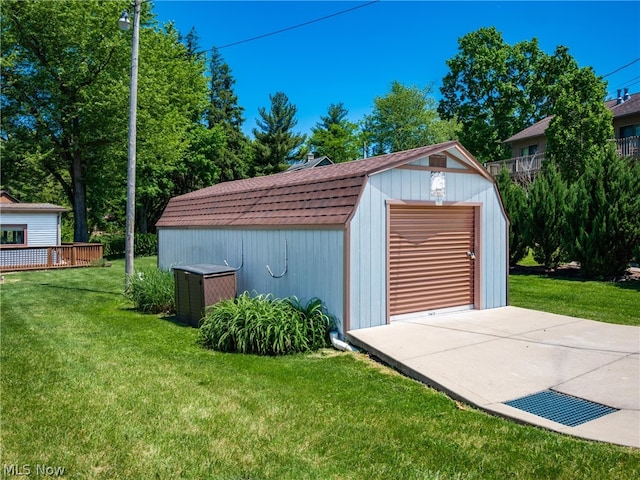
151,0,640,134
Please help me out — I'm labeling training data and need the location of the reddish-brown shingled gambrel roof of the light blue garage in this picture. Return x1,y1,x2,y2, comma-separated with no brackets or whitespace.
156,141,493,227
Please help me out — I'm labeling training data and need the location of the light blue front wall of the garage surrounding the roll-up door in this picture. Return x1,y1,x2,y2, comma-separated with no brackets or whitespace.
349,161,507,330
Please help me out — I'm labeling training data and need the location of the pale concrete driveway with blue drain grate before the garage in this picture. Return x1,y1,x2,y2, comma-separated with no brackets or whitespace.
347,307,640,448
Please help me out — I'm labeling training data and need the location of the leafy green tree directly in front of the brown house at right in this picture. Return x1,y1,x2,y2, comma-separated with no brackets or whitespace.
545,64,614,184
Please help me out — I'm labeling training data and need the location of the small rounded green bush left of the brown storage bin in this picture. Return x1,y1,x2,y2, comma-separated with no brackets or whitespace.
126,268,176,314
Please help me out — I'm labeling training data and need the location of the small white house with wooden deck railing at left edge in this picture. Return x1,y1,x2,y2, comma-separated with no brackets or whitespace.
0,190,102,271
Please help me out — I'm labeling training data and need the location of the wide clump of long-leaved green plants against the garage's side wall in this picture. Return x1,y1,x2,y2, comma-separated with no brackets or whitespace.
199,292,334,355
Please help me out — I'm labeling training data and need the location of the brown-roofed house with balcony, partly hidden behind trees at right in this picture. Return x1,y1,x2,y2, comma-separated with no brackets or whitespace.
486,89,640,179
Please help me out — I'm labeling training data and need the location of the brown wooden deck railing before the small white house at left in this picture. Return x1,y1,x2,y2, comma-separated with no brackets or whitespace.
0,243,102,272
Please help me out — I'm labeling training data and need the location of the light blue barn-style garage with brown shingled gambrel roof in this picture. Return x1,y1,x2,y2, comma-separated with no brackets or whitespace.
156,141,508,334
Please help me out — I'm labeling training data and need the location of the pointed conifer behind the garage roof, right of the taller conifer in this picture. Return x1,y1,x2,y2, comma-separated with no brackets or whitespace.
253,92,306,175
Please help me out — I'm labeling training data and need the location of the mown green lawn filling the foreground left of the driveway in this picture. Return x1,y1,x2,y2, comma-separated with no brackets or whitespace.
0,259,640,479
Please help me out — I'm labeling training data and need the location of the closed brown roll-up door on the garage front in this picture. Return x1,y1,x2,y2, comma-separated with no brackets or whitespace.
389,205,475,315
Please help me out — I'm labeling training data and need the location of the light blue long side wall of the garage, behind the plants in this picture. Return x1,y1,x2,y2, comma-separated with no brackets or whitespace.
158,228,344,327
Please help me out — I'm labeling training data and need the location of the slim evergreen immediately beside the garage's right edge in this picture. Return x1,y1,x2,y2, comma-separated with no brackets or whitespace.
497,168,529,266
